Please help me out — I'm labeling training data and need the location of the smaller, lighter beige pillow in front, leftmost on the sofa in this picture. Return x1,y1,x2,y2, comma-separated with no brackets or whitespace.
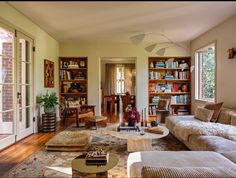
194,107,214,122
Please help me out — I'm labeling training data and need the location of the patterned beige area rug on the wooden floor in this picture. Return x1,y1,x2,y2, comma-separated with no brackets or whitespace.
4,125,188,178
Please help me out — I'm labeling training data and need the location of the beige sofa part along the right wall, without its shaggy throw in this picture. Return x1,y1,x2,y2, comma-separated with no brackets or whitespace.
166,108,236,153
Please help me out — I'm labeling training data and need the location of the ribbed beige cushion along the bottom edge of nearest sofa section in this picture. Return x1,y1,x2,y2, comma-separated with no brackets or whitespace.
141,166,236,178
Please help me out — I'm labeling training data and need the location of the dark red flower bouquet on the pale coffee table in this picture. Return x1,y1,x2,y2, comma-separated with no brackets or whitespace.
124,104,140,126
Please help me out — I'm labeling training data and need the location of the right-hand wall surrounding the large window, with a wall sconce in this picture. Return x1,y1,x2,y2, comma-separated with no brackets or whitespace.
191,15,236,112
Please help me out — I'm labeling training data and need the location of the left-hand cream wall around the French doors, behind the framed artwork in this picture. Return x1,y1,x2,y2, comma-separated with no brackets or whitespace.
0,2,59,130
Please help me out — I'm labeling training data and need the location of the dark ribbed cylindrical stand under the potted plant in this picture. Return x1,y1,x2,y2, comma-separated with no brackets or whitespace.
42,113,56,132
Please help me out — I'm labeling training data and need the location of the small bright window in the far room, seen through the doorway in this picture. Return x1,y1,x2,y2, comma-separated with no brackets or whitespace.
116,67,125,94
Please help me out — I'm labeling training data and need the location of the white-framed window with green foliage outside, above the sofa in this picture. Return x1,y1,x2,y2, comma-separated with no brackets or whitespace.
195,43,216,102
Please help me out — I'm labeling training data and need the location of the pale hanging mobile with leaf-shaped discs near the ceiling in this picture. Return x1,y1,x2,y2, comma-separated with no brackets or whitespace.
130,33,187,56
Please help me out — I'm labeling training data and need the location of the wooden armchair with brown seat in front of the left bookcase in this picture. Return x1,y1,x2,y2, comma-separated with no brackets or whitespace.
63,100,96,127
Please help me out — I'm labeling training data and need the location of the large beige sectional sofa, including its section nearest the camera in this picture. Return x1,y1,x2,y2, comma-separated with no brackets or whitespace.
127,108,236,177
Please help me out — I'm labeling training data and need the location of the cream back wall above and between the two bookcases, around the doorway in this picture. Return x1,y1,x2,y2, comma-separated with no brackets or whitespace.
59,42,190,115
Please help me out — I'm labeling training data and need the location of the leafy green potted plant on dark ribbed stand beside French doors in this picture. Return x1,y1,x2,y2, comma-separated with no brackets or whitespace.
36,91,58,113
